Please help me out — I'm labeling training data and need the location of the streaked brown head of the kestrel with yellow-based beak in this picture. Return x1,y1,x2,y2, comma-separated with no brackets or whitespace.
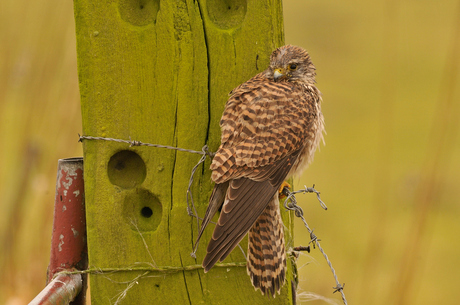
266,45,316,84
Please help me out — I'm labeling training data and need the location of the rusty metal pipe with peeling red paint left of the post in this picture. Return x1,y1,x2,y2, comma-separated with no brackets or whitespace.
29,158,88,305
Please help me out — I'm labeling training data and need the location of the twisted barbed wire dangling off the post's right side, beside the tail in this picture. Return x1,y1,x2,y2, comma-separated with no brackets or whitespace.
283,185,348,305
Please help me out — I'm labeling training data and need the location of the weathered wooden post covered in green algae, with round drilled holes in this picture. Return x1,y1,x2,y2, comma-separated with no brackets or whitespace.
74,0,293,304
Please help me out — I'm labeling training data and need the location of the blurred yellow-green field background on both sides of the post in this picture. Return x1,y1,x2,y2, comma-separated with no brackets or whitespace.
0,0,460,305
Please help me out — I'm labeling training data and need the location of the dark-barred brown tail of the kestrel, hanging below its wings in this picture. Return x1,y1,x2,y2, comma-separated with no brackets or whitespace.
247,194,286,297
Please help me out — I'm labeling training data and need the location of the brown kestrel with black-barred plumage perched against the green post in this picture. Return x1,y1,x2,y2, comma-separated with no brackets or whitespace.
198,45,324,297
